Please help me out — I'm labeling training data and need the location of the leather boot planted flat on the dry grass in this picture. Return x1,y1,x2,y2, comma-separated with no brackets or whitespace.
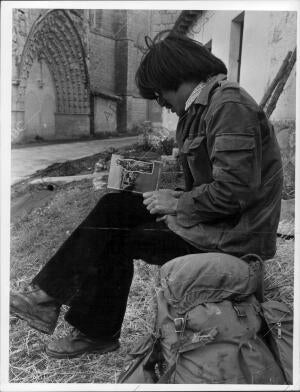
45,329,120,359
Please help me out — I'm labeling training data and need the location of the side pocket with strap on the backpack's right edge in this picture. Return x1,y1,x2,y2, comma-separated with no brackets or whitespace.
261,301,293,384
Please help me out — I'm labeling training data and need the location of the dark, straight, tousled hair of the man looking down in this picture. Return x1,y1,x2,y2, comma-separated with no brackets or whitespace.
135,31,227,99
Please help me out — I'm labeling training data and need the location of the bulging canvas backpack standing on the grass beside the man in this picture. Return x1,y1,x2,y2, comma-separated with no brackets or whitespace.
118,253,287,384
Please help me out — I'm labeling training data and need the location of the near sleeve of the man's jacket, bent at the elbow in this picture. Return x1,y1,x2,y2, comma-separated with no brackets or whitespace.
177,102,261,227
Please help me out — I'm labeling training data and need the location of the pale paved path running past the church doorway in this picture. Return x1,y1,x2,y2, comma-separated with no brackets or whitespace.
11,136,137,184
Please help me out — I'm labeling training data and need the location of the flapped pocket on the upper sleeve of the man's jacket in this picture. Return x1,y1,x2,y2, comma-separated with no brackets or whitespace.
212,133,261,187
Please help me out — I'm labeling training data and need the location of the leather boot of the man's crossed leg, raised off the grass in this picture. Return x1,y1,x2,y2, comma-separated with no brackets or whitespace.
10,286,61,335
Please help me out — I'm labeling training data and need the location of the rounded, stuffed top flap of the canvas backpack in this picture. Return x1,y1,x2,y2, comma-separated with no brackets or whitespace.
160,253,258,314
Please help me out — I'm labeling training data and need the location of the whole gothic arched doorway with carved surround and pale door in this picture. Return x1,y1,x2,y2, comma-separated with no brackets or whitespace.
18,10,90,139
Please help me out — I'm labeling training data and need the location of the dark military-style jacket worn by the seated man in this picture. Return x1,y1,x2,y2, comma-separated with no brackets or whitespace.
167,75,283,259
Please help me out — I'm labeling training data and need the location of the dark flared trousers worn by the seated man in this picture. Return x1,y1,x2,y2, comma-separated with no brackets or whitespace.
33,192,201,338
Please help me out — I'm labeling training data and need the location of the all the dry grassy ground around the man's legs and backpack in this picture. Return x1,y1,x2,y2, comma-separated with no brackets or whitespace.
10,162,294,383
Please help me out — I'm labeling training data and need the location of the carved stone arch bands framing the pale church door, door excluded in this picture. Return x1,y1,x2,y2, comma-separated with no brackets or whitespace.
17,10,90,137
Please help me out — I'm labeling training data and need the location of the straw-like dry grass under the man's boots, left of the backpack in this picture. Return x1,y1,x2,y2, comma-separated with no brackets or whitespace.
10,261,157,383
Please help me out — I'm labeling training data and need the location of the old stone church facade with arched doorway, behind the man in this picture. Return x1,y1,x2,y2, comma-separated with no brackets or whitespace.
12,8,180,141
